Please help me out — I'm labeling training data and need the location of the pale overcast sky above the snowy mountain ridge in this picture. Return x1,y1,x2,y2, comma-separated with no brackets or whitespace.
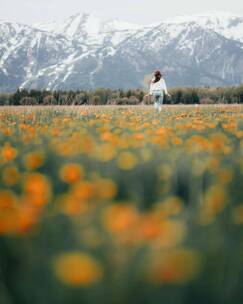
0,0,243,24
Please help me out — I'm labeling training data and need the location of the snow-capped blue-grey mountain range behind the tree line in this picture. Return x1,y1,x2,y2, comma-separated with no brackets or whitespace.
0,13,243,91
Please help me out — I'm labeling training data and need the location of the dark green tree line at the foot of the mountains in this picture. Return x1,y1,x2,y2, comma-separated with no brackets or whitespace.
0,85,243,106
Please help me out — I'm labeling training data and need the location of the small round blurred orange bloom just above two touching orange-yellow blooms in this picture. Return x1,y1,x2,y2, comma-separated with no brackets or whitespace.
60,163,84,184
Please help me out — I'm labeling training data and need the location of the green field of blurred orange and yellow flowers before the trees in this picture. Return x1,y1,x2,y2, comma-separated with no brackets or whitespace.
0,105,243,304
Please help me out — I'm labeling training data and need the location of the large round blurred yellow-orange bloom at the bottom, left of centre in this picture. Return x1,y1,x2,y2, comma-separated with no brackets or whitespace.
54,252,103,287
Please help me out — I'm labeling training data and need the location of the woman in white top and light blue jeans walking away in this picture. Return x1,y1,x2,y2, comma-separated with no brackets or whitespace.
148,71,170,112
